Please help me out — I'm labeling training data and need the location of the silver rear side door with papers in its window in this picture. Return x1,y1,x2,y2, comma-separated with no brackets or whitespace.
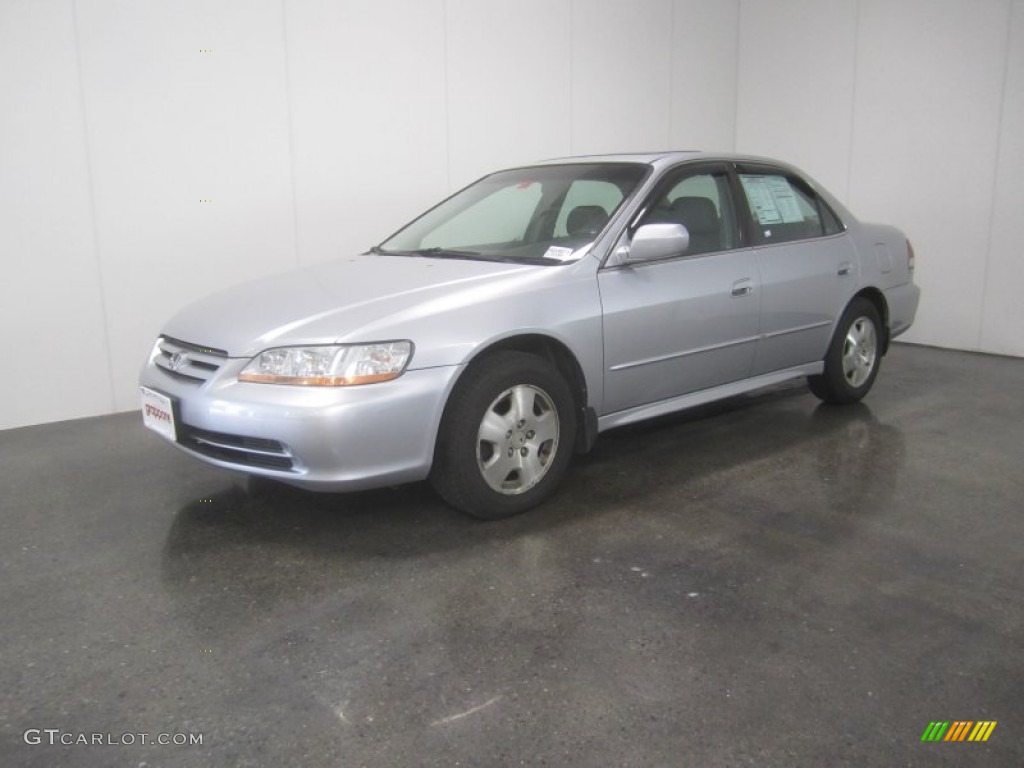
736,165,856,376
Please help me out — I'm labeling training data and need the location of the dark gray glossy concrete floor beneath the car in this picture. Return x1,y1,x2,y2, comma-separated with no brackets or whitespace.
0,345,1024,768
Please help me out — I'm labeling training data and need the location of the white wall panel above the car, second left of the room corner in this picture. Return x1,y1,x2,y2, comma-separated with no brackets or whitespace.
571,0,673,154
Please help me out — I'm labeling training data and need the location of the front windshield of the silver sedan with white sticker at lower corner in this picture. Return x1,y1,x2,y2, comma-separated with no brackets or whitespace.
374,163,649,264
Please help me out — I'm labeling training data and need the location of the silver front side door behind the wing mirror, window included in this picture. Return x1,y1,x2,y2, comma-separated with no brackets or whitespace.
598,164,760,414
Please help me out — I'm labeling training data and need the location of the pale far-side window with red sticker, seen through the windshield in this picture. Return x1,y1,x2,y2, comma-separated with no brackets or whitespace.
420,182,542,248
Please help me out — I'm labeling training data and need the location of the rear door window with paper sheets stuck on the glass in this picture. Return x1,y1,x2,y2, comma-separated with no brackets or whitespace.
739,173,843,245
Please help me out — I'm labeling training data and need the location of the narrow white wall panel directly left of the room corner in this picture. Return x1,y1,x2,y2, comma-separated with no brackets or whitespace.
669,0,739,152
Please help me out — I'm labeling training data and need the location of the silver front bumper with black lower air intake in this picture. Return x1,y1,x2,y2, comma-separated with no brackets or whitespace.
139,358,459,490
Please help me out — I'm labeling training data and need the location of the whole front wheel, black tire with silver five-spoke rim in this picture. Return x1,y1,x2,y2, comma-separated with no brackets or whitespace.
430,351,577,520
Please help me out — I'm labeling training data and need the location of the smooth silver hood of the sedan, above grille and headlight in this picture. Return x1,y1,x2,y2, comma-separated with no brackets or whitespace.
163,255,544,357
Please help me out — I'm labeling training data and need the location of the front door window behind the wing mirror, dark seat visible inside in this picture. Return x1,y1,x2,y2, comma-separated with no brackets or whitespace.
640,171,738,256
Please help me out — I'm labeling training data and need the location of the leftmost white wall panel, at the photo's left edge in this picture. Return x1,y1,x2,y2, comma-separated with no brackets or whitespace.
0,0,113,429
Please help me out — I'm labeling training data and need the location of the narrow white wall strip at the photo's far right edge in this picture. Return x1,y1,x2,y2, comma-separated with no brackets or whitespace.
981,0,1024,356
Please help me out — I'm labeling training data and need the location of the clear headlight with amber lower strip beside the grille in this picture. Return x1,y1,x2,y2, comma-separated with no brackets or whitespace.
239,341,413,387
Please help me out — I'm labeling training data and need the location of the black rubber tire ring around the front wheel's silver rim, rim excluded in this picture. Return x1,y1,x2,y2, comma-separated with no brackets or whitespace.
430,351,577,520
